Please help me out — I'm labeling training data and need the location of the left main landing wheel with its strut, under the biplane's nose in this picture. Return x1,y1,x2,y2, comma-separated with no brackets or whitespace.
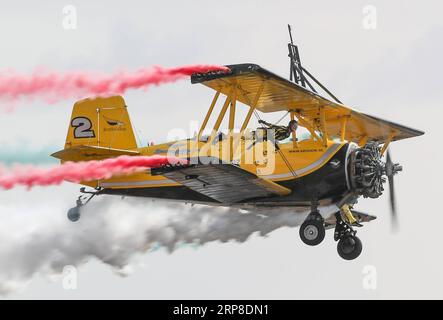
299,201,325,246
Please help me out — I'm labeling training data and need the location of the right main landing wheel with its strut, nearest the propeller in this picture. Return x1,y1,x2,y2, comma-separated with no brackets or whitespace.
334,212,363,260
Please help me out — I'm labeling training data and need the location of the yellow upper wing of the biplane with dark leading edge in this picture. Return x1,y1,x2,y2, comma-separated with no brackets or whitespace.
191,64,424,142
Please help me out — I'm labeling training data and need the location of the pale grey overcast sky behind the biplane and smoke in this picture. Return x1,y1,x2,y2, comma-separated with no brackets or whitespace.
0,1,443,299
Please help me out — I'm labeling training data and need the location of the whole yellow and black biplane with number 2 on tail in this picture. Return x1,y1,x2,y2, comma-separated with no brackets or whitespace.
52,28,423,260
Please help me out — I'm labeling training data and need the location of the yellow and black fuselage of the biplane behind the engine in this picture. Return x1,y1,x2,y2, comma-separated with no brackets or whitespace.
95,137,356,205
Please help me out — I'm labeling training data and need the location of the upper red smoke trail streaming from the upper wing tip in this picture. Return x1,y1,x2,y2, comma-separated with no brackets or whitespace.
0,65,229,102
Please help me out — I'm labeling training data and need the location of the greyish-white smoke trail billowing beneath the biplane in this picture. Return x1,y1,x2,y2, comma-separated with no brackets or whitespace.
0,196,336,294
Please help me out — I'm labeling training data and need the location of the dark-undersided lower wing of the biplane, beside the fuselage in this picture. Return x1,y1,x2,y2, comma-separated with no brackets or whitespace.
151,159,291,203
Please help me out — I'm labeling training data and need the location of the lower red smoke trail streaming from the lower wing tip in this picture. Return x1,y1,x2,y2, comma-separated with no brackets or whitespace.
0,156,186,189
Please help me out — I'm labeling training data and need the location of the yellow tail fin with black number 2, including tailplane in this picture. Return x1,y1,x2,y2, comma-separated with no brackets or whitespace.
52,96,137,161
